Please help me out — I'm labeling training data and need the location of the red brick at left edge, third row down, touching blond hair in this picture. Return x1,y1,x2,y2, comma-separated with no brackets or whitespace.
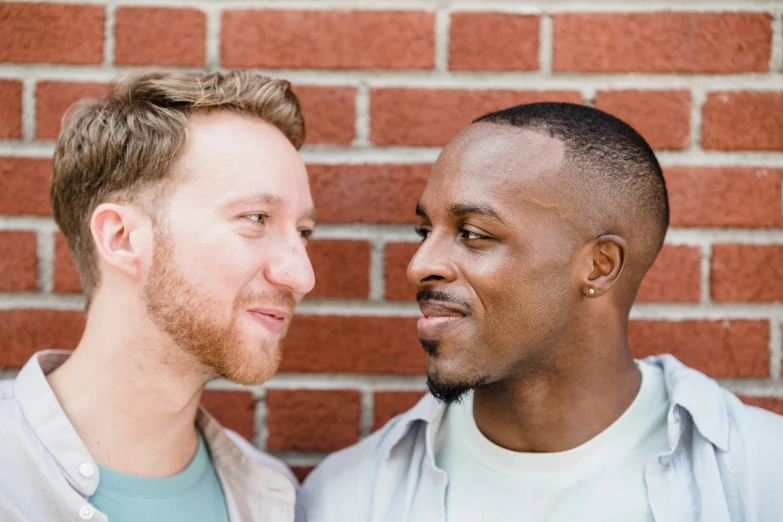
0,156,52,216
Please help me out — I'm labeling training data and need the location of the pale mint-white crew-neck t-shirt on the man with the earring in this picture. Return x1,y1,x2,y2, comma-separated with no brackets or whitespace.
435,361,669,522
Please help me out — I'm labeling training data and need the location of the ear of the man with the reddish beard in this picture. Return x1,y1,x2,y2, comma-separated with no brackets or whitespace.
90,203,147,277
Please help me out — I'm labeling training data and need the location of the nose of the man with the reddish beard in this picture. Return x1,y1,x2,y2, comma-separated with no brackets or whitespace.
265,232,315,299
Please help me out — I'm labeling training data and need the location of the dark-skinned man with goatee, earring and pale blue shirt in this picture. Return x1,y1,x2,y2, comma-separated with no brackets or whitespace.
297,103,783,522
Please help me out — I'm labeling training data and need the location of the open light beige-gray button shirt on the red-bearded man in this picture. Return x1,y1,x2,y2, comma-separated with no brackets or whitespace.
0,350,297,522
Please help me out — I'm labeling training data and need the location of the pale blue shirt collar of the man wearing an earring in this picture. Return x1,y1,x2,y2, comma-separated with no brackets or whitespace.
386,354,729,459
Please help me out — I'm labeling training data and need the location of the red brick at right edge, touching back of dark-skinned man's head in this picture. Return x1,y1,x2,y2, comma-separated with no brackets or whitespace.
664,167,783,228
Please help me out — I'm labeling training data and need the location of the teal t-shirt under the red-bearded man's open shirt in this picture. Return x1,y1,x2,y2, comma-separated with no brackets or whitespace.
90,433,228,522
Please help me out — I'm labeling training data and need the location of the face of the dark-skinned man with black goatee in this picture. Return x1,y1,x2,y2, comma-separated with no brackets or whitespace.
408,123,582,402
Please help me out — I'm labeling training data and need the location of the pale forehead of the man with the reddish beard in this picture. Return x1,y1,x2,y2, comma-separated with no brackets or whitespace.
175,111,312,207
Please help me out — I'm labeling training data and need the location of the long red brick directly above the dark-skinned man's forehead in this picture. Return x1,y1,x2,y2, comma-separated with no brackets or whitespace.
370,88,582,147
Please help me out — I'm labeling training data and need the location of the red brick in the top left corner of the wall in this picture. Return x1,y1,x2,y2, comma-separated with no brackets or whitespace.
0,3,104,64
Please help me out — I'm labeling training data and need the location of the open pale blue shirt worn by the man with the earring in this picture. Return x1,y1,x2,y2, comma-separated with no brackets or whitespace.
296,355,783,522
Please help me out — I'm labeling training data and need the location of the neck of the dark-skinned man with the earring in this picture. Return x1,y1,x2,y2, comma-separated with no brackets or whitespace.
473,318,641,452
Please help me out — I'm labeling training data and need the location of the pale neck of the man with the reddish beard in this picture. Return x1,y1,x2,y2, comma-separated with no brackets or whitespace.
47,290,208,477
